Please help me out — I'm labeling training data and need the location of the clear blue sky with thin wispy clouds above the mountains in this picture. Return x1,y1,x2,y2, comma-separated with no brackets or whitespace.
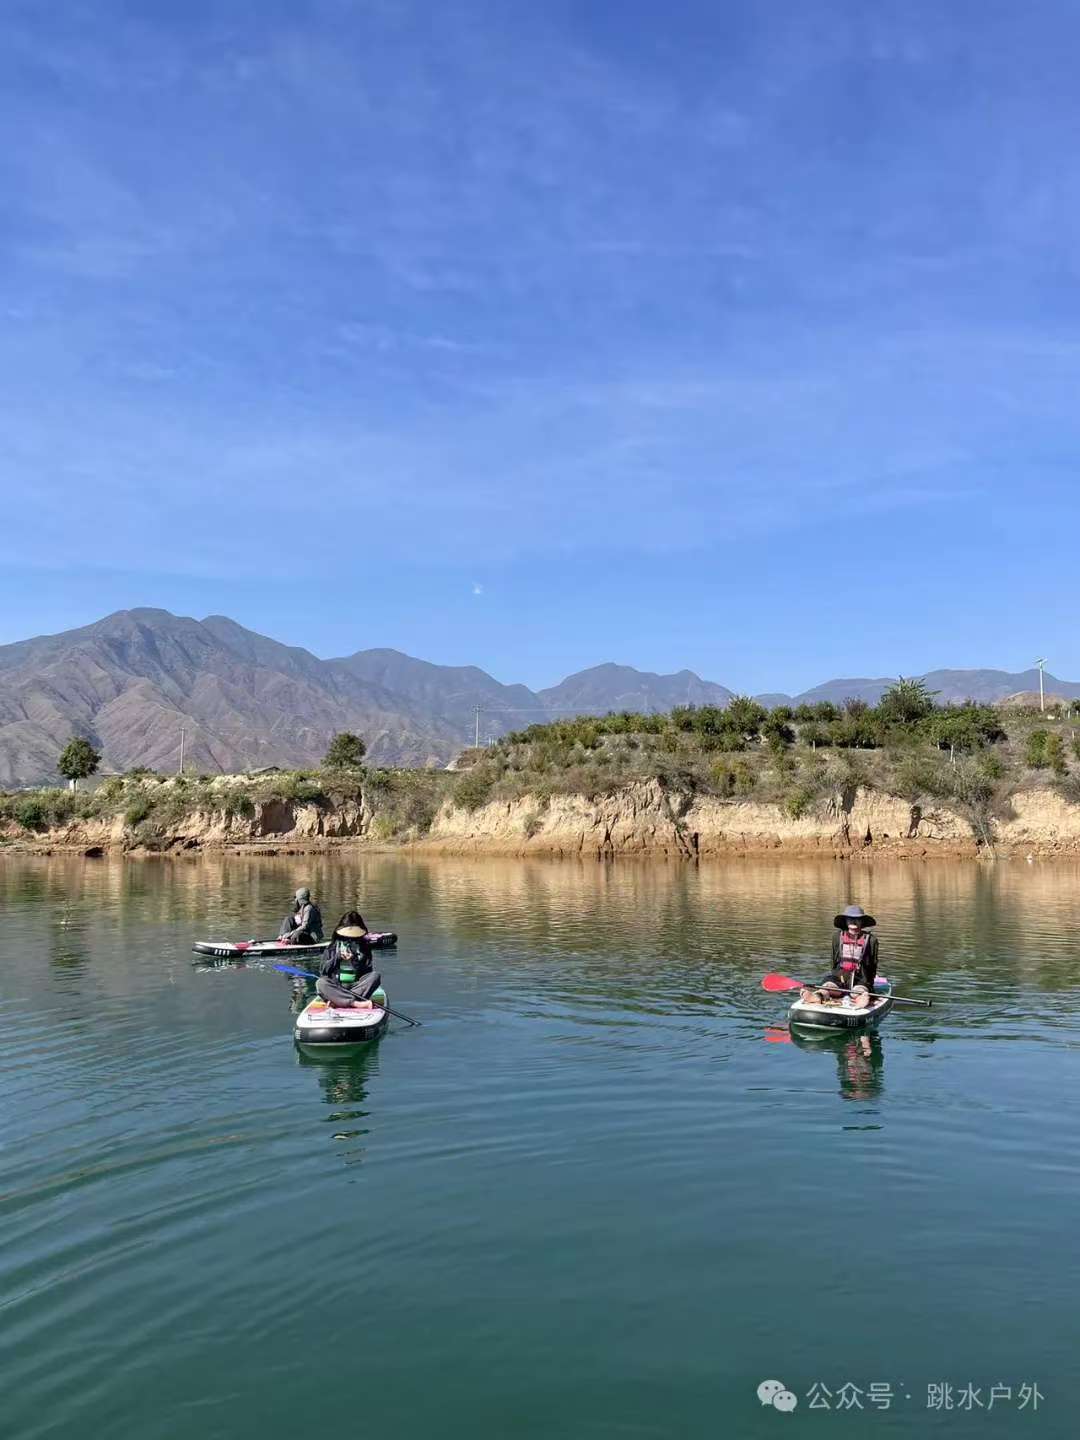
0,0,1080,691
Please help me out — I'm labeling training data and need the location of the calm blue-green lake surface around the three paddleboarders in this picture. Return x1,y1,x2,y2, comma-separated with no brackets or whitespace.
0,857,1080,1440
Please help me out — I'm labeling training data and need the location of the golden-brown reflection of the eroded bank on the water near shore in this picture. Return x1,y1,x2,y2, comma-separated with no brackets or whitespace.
0,850,1080,1027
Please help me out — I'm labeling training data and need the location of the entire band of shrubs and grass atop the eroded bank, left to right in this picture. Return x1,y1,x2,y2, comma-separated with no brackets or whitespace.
0,681,1080,844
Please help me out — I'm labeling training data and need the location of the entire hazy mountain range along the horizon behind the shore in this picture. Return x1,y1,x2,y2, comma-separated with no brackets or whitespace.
0,609,1080,786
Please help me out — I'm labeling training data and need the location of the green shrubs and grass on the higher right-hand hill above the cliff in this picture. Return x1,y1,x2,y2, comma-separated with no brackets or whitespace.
455,680,1080,841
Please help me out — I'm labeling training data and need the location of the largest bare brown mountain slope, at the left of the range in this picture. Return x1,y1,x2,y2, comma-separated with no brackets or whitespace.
0,611,464,785
